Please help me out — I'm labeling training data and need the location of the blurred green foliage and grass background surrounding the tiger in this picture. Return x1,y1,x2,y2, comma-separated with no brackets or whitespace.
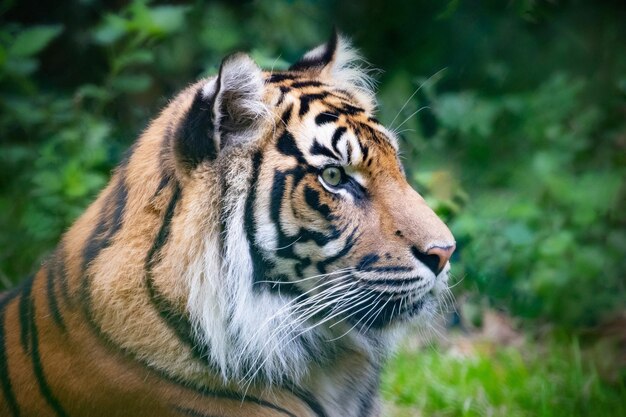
0,0,626,416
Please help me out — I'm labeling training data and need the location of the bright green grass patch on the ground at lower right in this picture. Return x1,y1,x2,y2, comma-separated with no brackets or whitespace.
382,339,626,417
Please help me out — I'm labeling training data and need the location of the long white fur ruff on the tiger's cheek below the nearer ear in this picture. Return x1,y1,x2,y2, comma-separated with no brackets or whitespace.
187,154,332,384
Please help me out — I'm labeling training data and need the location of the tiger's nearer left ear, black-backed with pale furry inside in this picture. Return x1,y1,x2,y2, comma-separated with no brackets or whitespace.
174,54,266,169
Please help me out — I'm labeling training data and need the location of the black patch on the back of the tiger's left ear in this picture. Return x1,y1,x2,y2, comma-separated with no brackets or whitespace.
174,85,219,169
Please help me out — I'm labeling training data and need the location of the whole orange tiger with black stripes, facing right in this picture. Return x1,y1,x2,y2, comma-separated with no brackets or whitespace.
0,34,455,417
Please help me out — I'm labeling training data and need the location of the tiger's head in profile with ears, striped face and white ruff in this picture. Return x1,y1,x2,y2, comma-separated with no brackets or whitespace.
158,35,455,379
